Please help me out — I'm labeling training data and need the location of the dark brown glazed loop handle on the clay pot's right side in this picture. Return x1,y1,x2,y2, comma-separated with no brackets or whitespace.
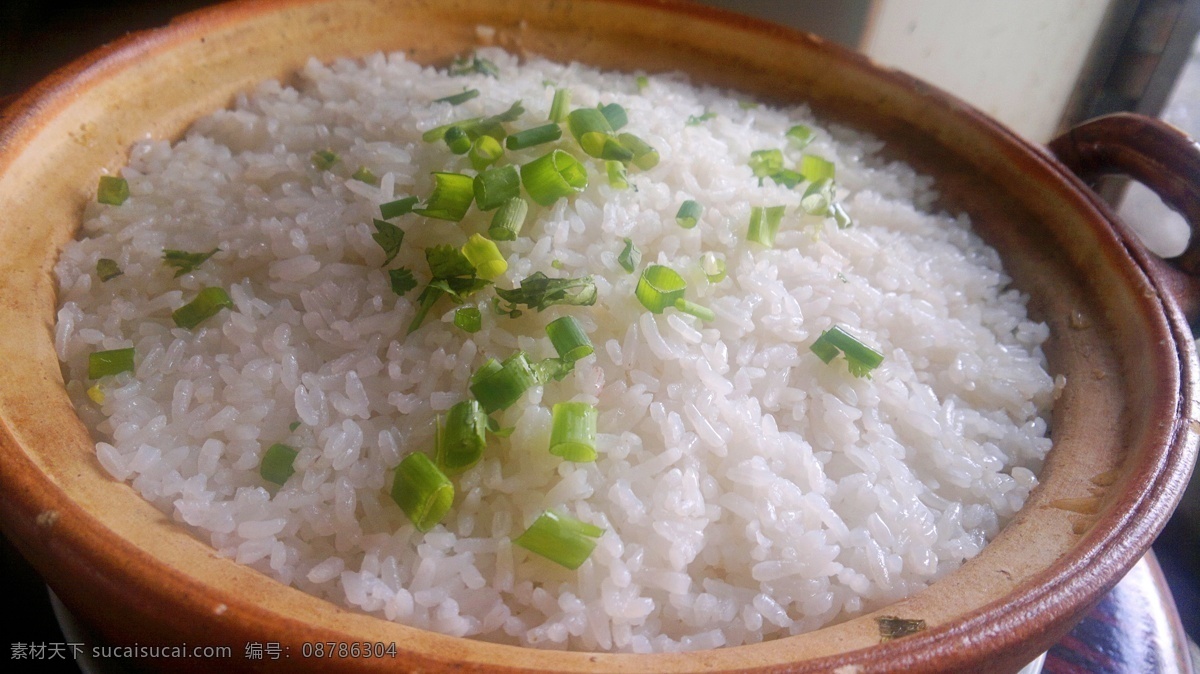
1050,113,1200,332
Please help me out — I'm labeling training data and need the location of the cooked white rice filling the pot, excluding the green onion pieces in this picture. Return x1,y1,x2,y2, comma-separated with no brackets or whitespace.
56,50,1054,652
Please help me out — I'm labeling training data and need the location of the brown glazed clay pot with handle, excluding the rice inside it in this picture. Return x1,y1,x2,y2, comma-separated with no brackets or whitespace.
0,0,1200,673
